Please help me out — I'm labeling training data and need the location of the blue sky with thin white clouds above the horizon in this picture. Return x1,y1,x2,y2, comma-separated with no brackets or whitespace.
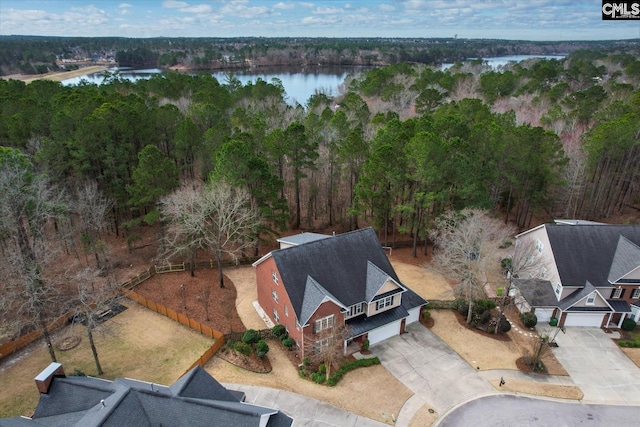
0,0,640,41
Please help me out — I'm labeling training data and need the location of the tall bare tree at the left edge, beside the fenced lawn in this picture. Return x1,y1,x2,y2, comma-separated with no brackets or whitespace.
0,147,66,362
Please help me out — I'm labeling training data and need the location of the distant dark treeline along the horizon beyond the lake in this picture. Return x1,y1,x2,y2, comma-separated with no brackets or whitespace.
0,36,634,75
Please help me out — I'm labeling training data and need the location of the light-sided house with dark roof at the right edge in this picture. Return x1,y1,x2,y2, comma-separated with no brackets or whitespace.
514,220,640,328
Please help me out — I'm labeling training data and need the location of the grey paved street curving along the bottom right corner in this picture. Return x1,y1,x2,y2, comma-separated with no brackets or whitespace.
436,395,640,427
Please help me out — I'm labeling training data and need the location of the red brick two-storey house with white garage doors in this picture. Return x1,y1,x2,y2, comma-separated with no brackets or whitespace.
253,228,427,358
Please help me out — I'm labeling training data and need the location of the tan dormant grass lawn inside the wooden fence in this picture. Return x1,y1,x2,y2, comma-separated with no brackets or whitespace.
0,301,213,417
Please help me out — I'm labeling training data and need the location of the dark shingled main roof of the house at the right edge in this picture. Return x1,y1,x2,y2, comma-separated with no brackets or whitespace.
546,224,640,287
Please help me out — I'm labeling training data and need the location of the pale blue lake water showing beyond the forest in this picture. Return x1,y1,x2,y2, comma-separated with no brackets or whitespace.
62,55,565,105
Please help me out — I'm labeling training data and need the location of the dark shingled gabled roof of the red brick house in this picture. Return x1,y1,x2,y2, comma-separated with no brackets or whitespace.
271,227,426,325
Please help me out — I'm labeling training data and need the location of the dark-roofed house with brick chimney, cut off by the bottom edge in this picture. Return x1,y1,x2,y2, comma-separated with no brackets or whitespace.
0,363,293,427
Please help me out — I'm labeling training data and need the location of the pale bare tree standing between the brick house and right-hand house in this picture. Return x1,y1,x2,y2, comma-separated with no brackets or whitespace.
430,208,514,323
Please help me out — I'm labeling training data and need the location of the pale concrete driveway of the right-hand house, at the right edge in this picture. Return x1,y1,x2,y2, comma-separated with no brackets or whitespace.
553,328,640,405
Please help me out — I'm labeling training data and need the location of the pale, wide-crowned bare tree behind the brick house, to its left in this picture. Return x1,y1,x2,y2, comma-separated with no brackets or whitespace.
160,181,259,288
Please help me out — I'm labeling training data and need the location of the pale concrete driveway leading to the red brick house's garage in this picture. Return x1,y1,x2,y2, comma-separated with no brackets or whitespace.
371,323,496,425
